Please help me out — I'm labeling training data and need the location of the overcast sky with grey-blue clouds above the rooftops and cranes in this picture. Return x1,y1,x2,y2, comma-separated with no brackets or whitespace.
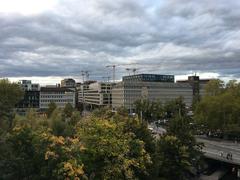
0,0,240,84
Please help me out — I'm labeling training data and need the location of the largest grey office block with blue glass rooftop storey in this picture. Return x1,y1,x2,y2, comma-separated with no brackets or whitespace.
112,74,192,110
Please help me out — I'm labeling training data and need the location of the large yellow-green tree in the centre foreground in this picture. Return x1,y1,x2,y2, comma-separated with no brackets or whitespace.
78,118,151,179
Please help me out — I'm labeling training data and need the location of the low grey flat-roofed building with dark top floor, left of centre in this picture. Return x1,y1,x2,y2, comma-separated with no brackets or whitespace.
40,87,76,109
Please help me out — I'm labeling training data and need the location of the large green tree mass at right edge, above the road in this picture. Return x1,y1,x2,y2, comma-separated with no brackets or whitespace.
195,81,240,132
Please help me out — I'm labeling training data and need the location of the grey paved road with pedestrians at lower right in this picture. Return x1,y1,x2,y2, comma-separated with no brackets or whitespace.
196,137,240,165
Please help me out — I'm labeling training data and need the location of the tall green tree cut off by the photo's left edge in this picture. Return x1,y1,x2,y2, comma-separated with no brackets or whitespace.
0,79,23,129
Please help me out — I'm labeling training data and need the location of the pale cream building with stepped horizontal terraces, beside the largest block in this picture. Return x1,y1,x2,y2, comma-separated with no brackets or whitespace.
78,82,113,106
